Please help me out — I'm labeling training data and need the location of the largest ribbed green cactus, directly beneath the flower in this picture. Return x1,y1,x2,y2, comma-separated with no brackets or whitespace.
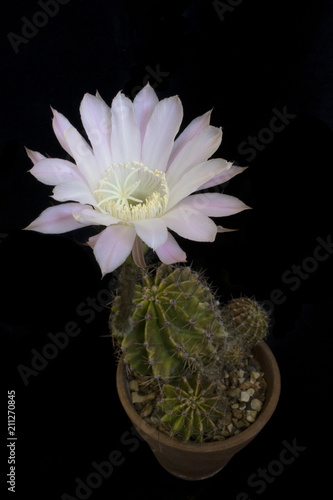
111,264,226,379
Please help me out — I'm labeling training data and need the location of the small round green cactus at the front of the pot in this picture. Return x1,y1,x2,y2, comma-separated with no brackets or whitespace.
158,374,223,442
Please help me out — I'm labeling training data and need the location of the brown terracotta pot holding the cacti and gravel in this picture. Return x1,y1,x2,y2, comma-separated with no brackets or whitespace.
117,342,281,481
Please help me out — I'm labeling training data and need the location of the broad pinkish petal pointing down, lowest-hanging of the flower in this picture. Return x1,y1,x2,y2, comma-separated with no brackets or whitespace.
88,225,136,276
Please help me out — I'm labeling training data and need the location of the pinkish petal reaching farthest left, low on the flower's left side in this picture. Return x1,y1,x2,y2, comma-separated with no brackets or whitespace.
25,203,88,234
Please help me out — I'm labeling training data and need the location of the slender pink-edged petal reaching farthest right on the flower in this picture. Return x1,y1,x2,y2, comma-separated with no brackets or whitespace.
177,193,250,217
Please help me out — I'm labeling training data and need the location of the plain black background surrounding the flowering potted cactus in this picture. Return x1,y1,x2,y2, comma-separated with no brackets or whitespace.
0,0,333,500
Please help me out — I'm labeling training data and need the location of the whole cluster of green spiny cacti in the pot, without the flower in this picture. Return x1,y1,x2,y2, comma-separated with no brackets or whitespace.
111,264,268,442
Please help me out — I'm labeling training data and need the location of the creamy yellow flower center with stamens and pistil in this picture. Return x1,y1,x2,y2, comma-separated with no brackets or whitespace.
95,162,169,222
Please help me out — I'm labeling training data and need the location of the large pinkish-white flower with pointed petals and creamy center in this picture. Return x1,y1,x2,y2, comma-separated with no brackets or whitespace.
26,84,248,275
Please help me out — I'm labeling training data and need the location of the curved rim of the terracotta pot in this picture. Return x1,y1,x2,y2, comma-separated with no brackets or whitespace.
117,341,281,453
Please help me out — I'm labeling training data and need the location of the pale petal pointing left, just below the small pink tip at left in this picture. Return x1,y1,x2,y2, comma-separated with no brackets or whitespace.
30,158,85,186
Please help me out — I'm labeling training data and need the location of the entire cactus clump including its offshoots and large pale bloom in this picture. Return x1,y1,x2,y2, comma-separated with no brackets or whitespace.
20,84,267,450
